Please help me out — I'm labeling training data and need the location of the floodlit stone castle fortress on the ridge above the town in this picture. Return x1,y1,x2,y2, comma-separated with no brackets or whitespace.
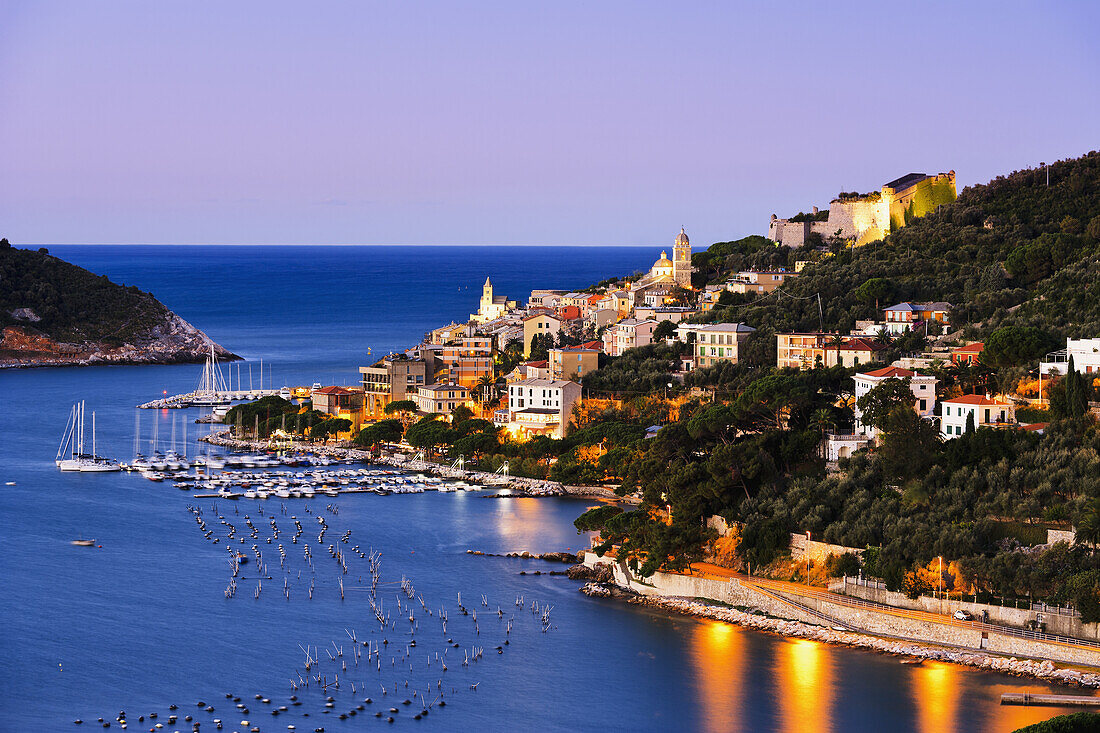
768,171,956,247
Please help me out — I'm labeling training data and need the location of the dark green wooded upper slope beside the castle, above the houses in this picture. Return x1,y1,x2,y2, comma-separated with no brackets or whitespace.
693,152,1100,349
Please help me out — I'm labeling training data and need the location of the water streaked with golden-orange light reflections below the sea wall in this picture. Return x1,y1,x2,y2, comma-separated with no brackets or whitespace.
681,620,1074,733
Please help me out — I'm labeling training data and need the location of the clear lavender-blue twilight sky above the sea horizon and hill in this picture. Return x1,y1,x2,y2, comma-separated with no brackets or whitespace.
0,0,1100,247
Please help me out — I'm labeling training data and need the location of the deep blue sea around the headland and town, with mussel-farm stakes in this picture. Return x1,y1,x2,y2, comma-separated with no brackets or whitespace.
0,245,1082,733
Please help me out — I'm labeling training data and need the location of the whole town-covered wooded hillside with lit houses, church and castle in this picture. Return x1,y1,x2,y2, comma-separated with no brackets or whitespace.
230,153,1100,647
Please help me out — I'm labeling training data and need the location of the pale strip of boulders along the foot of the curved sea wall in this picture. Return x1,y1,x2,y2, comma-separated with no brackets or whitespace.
580,581,1100,689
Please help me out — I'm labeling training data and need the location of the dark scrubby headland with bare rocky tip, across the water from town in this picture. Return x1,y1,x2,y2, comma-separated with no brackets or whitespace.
0,240,233,367
